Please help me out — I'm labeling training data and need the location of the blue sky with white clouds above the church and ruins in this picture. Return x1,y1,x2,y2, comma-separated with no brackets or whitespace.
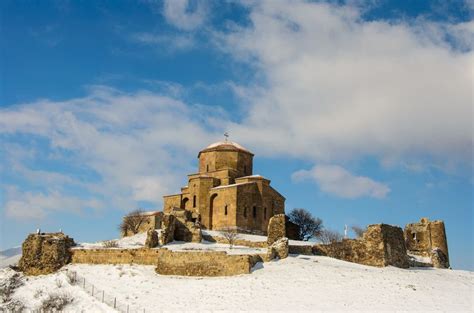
0,0,474,270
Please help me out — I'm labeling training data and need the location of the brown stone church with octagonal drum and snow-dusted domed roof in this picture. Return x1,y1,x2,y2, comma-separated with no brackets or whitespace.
163,140,285,234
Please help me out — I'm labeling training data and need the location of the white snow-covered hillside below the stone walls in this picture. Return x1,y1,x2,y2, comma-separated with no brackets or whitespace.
0,252,474,312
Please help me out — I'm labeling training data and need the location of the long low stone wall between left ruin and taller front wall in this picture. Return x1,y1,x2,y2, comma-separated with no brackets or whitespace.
70,248,159,265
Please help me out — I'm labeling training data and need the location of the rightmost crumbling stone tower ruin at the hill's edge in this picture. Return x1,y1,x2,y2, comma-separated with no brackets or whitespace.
404,217,449,268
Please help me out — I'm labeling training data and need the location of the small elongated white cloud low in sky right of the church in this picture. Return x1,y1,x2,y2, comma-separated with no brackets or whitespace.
292,165,390,199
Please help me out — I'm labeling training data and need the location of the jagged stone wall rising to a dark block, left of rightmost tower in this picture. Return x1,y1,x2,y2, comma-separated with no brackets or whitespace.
313,224,409,268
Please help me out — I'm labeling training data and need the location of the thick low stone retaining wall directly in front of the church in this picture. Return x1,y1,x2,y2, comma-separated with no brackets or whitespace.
156,249,256,276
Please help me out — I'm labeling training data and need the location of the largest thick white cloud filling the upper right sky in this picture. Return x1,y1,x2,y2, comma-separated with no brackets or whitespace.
217,1,474,172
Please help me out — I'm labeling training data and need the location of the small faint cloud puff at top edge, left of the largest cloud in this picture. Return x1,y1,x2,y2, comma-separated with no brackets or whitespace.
163,0,208,31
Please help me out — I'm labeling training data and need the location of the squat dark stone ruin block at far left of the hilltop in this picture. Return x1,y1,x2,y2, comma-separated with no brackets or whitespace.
19,233,75,275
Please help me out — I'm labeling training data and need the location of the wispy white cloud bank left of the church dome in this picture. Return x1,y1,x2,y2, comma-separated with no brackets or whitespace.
0,86,222,218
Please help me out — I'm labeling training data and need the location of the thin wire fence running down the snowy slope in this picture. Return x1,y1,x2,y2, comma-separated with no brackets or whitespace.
66,271,146,313
